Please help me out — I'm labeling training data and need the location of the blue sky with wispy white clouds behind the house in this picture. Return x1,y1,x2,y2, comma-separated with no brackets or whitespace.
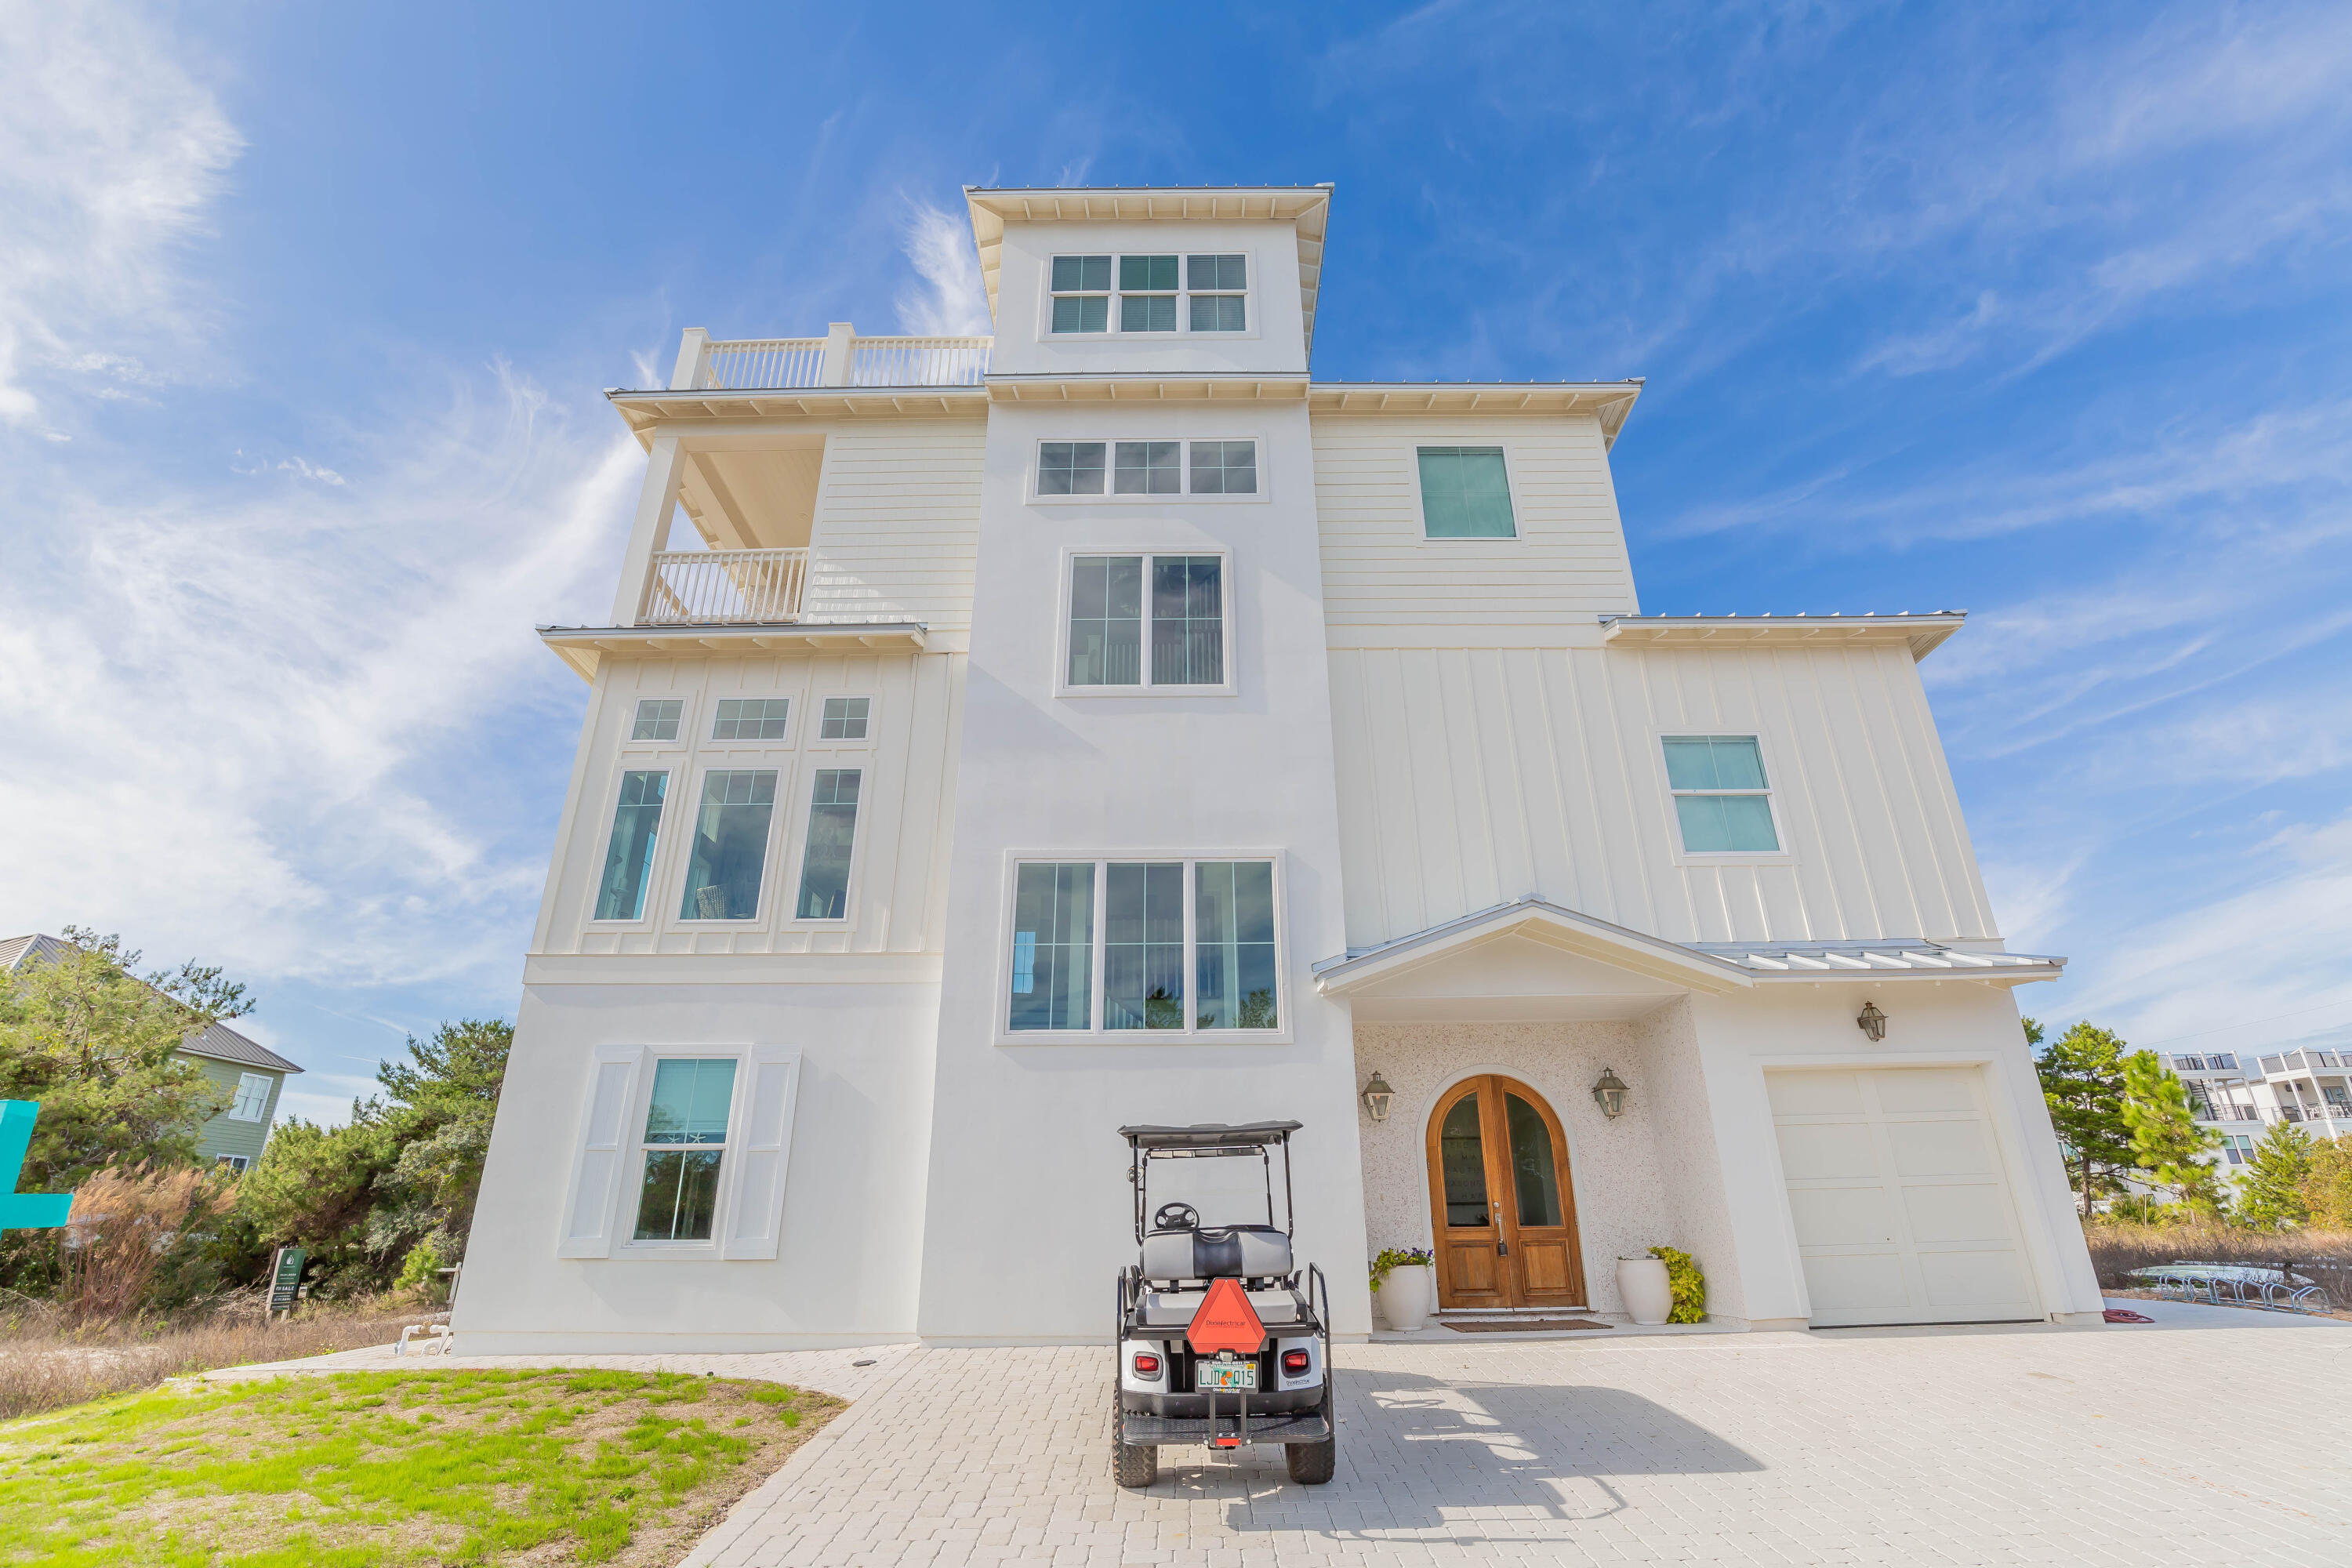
0,0,2352,1116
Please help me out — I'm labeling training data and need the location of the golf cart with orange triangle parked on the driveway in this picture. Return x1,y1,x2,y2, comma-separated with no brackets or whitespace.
1110,1121,1338,1486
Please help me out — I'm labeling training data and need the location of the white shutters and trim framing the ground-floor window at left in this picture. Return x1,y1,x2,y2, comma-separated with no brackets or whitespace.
555,1044,802,1262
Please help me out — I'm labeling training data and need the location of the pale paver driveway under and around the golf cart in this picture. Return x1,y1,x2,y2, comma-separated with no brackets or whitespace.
687,1302,2352,1568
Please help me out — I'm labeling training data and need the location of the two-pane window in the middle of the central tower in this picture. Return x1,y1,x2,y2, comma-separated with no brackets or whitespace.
1065,555,1225,689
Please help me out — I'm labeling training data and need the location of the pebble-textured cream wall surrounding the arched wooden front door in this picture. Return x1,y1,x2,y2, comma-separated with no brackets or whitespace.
1355,1022,1712,1314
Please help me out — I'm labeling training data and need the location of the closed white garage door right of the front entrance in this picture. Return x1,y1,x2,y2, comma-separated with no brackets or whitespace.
1764,1067,2042,1328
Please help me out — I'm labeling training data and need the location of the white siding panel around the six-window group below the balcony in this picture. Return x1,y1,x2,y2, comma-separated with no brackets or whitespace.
534,654,964,954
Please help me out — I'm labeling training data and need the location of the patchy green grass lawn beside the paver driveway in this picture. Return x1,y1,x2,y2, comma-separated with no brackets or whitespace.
0,1370,842,1568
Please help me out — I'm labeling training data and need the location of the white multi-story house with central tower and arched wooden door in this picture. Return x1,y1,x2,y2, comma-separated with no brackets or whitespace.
456,186,2100,1349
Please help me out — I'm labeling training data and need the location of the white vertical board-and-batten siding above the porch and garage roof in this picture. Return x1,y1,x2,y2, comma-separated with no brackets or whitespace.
1331,630,1997,947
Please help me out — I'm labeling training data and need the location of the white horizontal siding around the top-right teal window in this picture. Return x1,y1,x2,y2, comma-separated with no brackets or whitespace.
1312,414,1639,649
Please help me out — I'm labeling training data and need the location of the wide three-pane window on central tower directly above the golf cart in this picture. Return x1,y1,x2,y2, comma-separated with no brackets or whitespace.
1007,860,1282,1034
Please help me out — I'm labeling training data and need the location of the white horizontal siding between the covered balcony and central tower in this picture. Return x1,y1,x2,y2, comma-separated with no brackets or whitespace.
804,419,988,633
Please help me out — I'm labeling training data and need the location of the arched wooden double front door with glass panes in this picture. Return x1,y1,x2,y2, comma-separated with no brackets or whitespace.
1430,1074,1585,1307
